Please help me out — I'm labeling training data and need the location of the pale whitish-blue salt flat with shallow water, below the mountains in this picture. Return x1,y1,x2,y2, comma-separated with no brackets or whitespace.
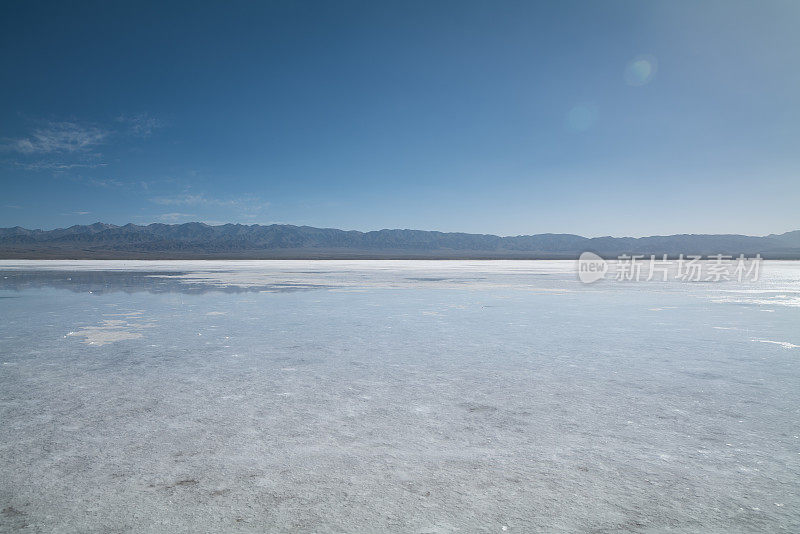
0,260,800,533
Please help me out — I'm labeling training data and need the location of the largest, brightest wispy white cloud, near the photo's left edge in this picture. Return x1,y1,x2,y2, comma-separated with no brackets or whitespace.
4,122,109,154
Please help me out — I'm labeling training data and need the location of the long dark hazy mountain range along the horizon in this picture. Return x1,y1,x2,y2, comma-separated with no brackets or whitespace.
0,222,800,259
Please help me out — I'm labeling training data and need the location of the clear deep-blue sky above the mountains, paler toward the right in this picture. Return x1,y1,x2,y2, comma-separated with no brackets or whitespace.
0,0,800,236
